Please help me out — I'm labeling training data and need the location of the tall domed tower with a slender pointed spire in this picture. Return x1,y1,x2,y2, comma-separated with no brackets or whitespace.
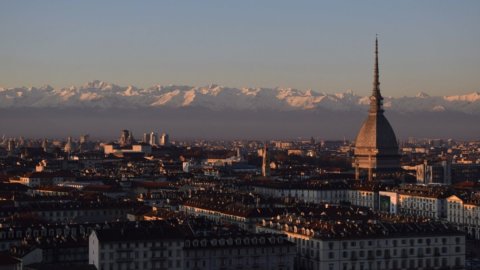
353,39,400,181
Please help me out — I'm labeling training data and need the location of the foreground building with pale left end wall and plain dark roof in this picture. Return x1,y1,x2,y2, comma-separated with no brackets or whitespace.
88,222,184,270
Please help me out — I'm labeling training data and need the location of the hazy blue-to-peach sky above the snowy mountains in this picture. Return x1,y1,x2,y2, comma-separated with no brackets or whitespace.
0,0,480,96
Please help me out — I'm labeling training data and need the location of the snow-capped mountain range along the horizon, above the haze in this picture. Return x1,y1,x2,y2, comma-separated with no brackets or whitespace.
0,81,480,114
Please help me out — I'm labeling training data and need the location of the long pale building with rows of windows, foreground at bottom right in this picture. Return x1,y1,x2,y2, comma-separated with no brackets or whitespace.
257,218,465,270
